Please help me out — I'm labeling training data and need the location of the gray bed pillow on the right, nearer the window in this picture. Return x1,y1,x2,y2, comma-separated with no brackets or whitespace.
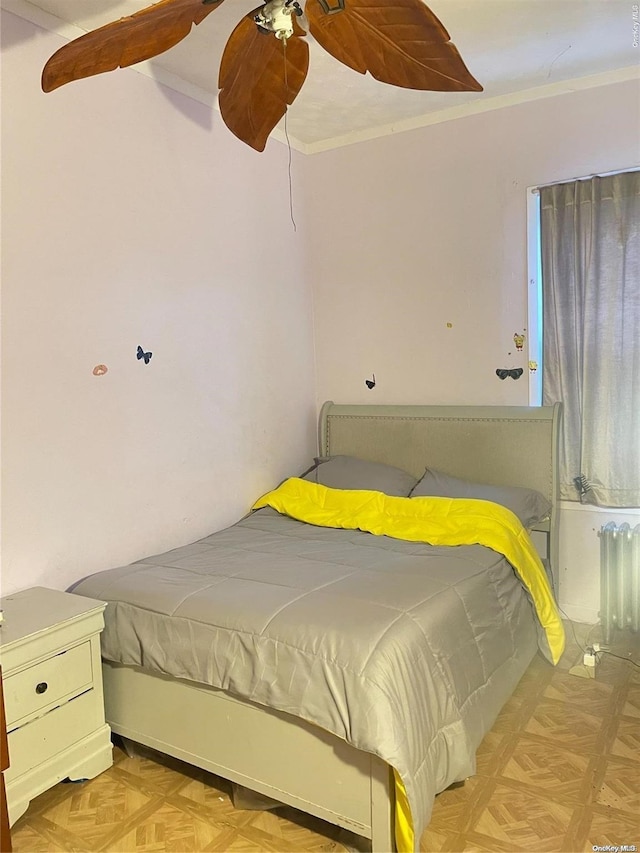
410,468,551,527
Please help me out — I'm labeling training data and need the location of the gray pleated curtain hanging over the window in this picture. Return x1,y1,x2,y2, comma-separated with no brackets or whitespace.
540,172,640,507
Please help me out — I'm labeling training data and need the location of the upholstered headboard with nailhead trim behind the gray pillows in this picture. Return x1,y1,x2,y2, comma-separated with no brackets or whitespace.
319,401,560,594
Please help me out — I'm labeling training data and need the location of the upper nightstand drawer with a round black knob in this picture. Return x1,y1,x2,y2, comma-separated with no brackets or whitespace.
4,642,93,731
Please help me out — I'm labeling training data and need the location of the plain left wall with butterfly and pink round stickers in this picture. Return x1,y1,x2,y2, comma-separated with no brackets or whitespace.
2,13,316,593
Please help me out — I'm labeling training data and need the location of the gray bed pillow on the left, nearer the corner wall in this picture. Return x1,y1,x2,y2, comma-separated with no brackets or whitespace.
301,456,417,498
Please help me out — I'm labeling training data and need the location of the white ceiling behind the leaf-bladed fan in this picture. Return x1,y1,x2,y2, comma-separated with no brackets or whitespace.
2,0,640,153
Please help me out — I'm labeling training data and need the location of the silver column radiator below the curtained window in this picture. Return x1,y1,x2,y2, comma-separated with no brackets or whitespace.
599,521,640,643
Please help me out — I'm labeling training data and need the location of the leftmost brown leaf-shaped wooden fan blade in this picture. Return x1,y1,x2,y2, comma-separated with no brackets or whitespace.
42,0,222,92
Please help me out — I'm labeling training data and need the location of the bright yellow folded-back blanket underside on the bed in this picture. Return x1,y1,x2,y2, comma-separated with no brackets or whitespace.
253,477,564,851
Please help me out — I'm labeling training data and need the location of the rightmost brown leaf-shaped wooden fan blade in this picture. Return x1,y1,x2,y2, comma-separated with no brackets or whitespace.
305,0,482,92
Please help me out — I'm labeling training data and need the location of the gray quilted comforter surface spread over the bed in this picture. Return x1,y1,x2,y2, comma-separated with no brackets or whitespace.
73,509,536,843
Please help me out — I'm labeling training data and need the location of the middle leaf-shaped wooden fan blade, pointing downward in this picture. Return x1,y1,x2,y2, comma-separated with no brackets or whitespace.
218,7,309,151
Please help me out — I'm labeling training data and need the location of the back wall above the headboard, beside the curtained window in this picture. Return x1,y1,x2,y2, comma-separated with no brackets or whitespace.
305,82,640,404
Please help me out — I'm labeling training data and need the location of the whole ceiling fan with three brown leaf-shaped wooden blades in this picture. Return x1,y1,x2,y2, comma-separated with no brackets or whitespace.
42,0,482,151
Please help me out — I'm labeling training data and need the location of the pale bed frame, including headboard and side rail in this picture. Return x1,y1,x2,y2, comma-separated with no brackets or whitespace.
103,402,560,853
